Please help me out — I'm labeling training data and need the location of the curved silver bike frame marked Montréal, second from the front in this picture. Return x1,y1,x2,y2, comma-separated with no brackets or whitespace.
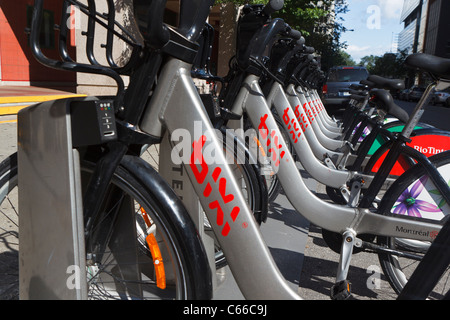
232,75,441,241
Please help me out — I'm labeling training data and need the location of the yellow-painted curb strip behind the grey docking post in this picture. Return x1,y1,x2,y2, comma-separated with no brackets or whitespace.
0,86,85,116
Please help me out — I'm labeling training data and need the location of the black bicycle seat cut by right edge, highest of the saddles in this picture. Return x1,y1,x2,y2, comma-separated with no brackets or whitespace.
405,53,450,80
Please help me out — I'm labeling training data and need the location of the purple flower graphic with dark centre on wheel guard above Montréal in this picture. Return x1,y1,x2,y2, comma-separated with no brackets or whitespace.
393,176,441,218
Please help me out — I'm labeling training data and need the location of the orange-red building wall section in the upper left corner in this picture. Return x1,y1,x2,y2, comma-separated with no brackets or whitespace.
0,0,76,90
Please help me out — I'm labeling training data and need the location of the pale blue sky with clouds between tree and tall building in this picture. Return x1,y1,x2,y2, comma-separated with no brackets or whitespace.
340,0,404,63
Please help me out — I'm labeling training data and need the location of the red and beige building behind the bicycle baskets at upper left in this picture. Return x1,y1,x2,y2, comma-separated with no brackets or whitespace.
0,0,230,95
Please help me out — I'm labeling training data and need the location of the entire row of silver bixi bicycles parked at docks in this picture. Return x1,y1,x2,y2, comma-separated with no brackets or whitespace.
0,0,450,300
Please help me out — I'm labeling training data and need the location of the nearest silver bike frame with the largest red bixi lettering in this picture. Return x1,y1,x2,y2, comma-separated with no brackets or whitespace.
140,59,300,300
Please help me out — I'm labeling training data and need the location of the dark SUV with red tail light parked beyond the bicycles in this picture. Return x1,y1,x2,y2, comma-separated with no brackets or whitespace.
322,66,369,114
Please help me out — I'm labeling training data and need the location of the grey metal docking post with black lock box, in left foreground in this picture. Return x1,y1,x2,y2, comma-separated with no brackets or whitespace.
18,97,117,300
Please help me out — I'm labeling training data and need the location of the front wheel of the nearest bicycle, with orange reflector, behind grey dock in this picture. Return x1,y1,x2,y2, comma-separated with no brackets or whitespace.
0,155,212,299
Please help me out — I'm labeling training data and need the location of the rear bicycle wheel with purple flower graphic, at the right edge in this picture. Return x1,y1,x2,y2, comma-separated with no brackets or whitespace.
377,152,450,299
